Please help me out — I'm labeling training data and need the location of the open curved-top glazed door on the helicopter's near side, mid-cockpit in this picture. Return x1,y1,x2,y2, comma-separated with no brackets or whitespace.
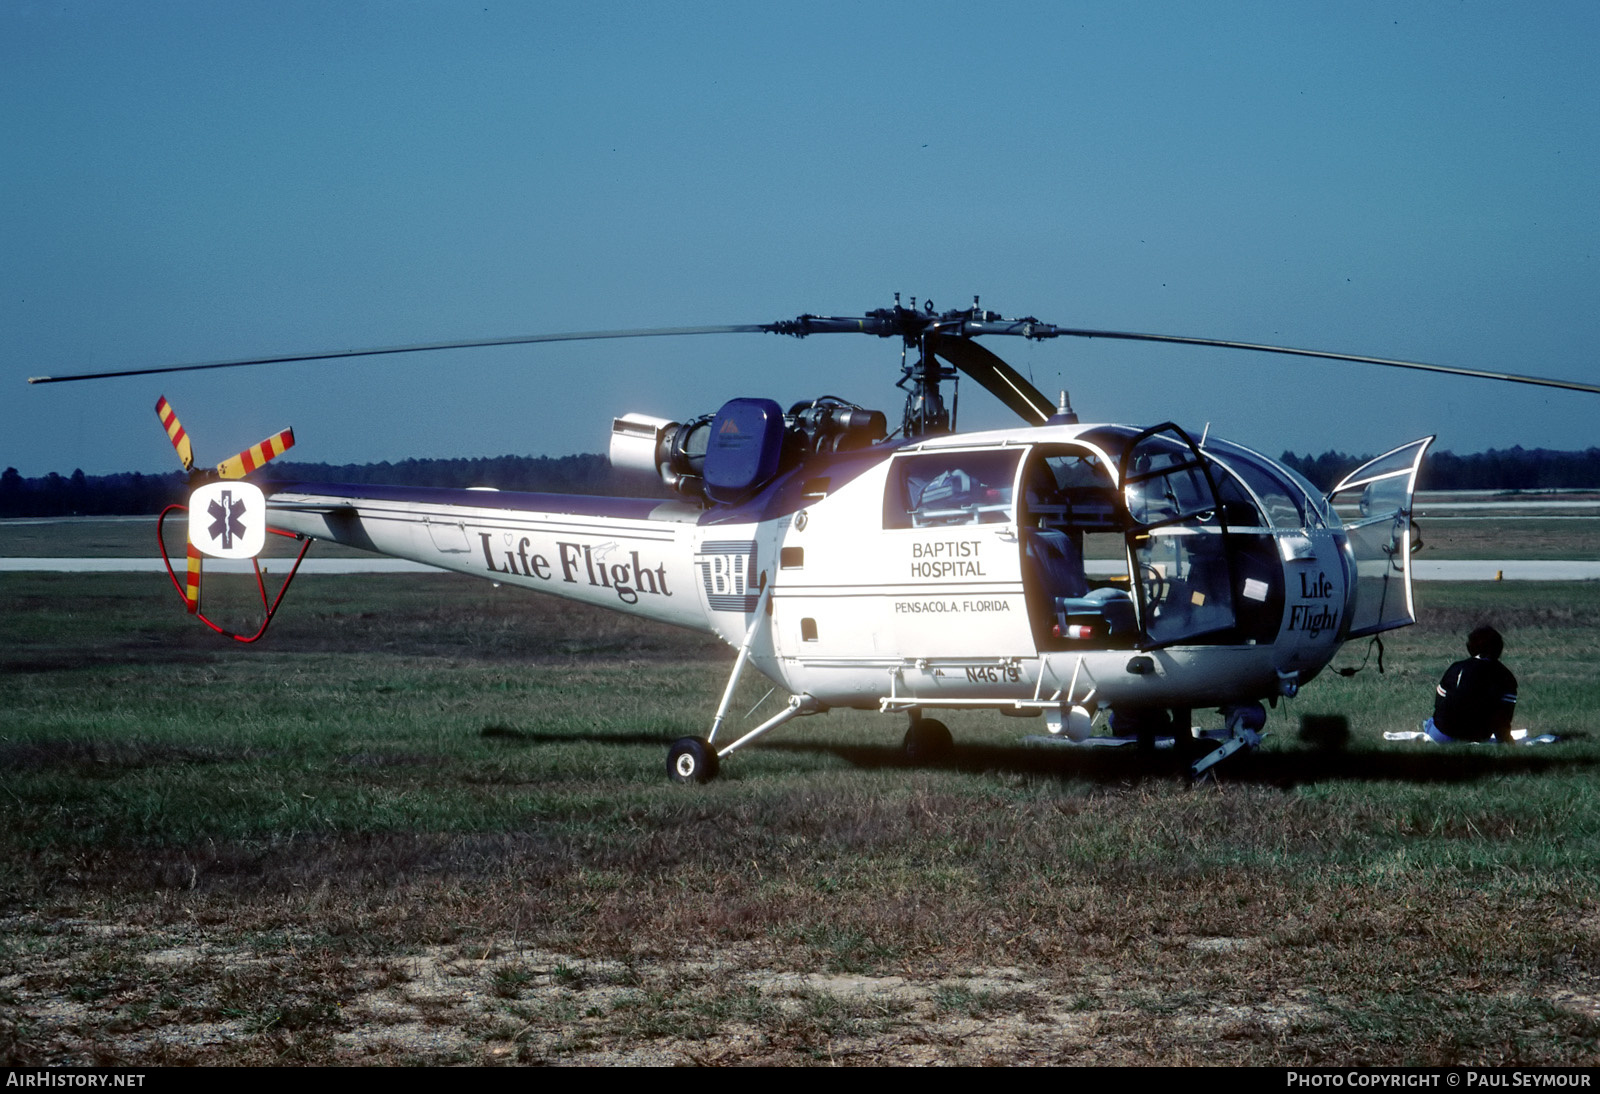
1118,422,1237,649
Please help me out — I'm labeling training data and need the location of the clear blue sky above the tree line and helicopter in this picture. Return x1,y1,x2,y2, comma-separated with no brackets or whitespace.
0,0,1600,477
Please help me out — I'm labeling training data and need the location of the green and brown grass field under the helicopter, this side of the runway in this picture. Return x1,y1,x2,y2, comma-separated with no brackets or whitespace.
0,562,1600,1065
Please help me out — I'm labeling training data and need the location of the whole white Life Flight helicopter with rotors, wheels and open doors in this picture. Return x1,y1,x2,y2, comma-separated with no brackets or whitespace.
29,294,1600,782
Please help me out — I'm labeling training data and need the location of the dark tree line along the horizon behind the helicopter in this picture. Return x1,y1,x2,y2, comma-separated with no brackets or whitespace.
0,446,1600,518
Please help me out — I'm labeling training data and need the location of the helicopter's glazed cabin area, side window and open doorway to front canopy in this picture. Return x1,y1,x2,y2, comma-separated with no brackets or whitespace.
883,424,1338,649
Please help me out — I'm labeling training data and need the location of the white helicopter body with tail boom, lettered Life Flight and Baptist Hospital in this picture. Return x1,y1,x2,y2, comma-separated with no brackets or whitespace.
267,424,1410,722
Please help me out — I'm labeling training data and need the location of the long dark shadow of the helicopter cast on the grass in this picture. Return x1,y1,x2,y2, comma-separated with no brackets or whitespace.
483,726,1600,787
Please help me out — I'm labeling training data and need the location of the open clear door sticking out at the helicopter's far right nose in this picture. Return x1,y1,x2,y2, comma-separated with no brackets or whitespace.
1328,437,1434,638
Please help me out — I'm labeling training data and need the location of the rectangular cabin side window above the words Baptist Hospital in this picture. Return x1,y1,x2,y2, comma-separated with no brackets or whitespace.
883,448,1021,528
